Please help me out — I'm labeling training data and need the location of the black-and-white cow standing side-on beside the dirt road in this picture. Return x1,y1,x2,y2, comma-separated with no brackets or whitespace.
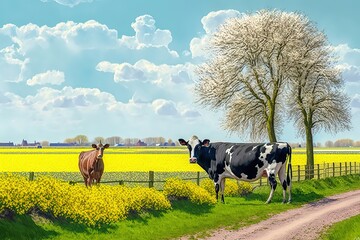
179,136,292,203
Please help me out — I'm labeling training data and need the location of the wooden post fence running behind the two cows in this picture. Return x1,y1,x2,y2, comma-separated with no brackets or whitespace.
23,162,360,189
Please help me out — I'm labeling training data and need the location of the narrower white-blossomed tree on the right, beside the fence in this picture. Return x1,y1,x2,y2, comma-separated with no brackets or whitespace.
287,15,351,178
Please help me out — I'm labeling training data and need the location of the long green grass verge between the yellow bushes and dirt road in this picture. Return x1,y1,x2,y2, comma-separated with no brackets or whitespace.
0,175,360,240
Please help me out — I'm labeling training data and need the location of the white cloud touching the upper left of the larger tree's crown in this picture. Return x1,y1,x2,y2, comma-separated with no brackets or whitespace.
190,9,240,58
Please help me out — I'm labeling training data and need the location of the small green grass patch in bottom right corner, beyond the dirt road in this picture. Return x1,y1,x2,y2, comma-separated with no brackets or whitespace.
321,215,360,240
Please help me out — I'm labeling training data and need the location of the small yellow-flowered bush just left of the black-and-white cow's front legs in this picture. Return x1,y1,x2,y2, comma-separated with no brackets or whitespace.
164,178,216,205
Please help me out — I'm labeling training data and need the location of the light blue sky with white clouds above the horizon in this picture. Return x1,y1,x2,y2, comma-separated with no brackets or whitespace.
0,0,360,143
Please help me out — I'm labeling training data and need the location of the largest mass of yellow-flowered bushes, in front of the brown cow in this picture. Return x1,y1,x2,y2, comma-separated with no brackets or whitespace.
0,175,171,226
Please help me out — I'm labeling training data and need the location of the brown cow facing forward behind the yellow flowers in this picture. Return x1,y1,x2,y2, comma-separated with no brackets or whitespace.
79,142,109,187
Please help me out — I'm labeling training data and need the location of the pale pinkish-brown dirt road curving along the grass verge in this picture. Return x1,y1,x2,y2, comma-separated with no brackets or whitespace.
182,190,360,240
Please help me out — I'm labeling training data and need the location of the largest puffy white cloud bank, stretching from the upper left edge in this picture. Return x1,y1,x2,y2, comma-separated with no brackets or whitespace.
0,15,179,82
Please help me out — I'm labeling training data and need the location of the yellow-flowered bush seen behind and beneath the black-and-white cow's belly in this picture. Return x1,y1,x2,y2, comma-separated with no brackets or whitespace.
200,179,253,196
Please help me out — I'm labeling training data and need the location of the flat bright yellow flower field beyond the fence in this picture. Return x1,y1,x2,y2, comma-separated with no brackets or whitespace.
0,147,360,172
